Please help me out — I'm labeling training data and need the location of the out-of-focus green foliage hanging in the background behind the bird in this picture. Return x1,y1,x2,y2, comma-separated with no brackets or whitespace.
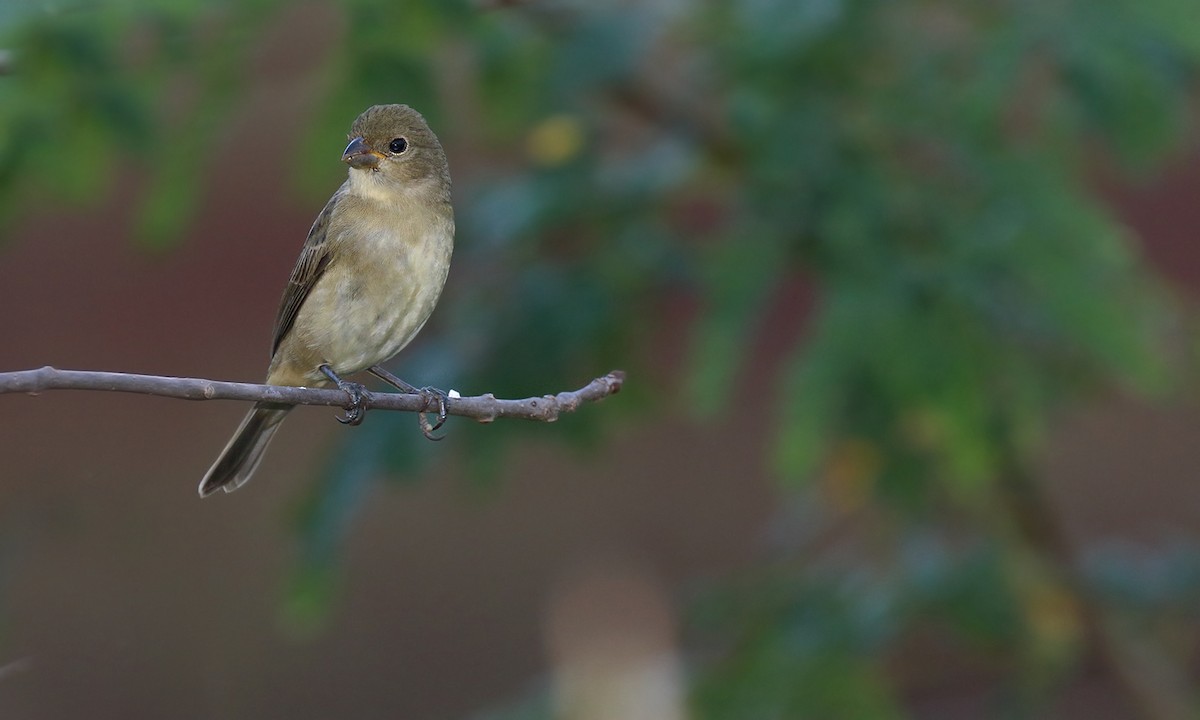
0,0,1200,718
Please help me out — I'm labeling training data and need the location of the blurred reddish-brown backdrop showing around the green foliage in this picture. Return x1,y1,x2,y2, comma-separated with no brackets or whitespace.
0,7,1200,719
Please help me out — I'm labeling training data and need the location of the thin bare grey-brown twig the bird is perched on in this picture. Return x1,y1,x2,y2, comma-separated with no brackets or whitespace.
0,365,625,422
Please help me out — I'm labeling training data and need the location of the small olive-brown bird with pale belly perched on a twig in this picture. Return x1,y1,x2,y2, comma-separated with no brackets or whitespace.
199,104,454,497
